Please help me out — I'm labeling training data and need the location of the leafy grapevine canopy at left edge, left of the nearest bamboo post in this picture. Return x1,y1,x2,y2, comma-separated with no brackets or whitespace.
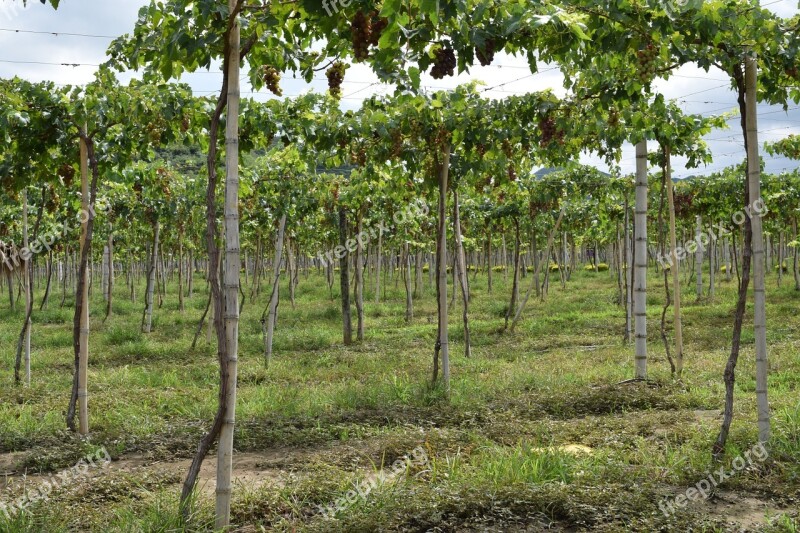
0,68,200,196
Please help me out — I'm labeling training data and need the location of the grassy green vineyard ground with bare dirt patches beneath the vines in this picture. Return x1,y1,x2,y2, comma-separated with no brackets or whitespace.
0,264,800,532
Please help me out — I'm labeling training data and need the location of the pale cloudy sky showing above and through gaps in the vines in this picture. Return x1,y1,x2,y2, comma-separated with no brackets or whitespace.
0,0,800,178
